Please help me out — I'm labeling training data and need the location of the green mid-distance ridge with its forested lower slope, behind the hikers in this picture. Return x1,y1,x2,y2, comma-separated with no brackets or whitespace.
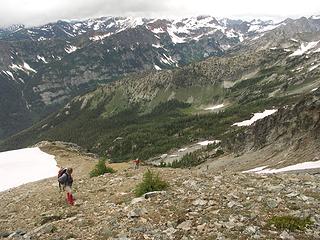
1,30,320,161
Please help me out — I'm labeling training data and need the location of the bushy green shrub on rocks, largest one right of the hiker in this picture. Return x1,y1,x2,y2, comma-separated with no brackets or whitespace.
134,169,169,197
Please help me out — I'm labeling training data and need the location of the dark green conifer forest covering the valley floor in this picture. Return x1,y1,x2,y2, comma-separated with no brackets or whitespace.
2,93,300,162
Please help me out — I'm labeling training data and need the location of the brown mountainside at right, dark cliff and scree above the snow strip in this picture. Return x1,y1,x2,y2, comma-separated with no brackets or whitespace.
195,90,320,172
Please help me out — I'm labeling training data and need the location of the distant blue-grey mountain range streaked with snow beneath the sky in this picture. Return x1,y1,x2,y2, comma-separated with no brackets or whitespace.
0,16,319,138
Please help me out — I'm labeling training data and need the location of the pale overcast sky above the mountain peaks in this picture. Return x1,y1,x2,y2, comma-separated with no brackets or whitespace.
0,0,320,26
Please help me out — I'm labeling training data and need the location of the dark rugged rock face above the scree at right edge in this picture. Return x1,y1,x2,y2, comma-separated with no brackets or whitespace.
226,90,320,156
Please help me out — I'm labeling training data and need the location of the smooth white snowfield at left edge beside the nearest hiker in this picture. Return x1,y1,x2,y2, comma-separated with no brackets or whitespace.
0,148,59,191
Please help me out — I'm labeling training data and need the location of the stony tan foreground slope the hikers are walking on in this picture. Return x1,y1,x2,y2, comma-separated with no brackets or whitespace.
0,142,320,239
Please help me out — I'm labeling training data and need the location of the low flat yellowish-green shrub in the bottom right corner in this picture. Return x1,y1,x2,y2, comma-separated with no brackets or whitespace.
268,216,312,231
